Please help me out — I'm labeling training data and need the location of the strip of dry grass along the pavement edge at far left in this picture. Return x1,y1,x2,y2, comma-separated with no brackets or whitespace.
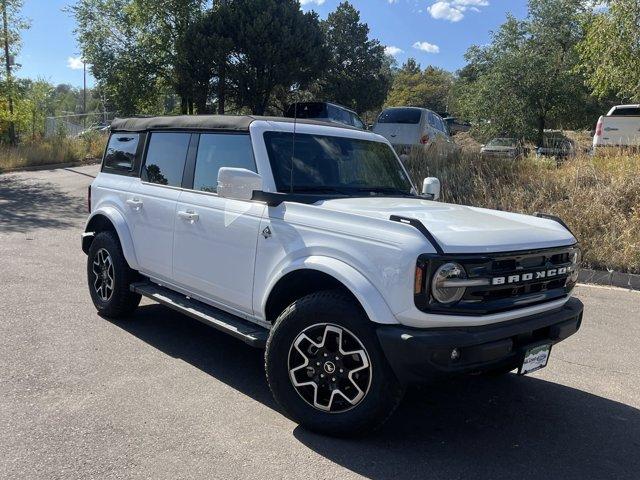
0,134,106,172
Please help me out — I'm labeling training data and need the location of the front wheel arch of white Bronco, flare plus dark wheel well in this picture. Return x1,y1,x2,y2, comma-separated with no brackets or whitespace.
261,256,398,324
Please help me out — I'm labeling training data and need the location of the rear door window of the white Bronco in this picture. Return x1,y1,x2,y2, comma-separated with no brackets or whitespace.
142,132,191,187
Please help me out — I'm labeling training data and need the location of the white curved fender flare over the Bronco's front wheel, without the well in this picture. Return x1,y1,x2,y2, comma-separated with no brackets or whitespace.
260,255,400,325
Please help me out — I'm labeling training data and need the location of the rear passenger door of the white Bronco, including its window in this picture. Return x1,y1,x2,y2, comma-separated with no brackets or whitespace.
127,132,191,281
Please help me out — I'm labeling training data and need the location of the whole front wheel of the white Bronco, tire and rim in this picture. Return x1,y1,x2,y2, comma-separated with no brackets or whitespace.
265,291,403,436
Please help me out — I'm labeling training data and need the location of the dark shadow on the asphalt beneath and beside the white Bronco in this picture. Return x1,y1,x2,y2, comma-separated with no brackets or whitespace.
115,305,640,480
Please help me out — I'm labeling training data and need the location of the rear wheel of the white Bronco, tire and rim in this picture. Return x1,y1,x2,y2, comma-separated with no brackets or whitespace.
87,232,141,318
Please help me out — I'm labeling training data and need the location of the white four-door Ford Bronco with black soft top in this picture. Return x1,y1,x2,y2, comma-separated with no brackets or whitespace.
82,116,583,435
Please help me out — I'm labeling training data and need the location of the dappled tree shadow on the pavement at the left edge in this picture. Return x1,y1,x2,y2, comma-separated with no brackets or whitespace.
0,174,86,233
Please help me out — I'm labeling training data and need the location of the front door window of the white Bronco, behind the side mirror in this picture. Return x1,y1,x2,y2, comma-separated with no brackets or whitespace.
193,133,256,192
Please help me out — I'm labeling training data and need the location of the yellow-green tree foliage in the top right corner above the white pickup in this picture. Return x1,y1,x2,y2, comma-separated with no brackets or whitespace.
578,0,640,102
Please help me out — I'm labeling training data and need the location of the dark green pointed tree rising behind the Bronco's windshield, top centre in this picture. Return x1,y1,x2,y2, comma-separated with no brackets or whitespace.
320,2,391,113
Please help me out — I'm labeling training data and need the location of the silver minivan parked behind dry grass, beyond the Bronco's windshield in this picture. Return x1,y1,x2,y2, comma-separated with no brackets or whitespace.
372,107,453,153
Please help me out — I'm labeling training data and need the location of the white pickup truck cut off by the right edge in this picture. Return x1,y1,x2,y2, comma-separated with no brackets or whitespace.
593,105,640,152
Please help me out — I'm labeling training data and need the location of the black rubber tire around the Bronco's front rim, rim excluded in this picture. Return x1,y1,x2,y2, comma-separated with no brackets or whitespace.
265,291,404,437
